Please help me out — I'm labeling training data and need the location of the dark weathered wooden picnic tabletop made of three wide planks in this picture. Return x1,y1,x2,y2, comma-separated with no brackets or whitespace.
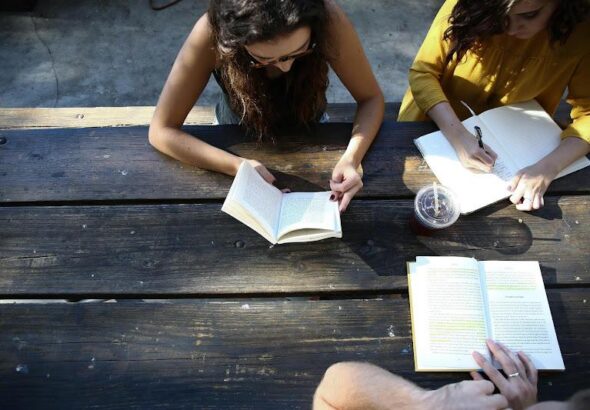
0,104,590,409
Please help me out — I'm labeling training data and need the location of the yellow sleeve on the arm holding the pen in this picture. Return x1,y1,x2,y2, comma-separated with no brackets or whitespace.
409,0,457,113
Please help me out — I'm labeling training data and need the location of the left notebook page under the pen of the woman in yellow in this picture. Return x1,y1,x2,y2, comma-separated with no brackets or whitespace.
416,117,518,213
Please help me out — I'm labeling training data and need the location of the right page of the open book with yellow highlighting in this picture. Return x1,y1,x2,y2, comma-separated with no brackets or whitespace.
480,261,564,370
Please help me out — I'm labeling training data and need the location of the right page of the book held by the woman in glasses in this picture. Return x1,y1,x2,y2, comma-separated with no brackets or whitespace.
277,191,340,238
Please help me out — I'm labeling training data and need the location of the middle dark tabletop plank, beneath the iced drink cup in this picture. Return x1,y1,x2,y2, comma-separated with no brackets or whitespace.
0,196,590,297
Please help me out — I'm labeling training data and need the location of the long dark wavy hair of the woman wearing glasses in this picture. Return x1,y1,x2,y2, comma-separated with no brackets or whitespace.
208,0,328,140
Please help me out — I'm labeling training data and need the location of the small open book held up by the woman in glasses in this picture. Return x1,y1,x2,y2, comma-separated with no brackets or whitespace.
221,161,342,244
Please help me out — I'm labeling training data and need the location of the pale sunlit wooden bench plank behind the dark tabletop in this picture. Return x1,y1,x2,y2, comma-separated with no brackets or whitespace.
0,103,400,129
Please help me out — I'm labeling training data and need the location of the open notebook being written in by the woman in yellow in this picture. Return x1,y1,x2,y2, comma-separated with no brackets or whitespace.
414,100,590,214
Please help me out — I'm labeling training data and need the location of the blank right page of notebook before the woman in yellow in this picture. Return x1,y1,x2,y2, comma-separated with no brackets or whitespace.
479,100,590,178
